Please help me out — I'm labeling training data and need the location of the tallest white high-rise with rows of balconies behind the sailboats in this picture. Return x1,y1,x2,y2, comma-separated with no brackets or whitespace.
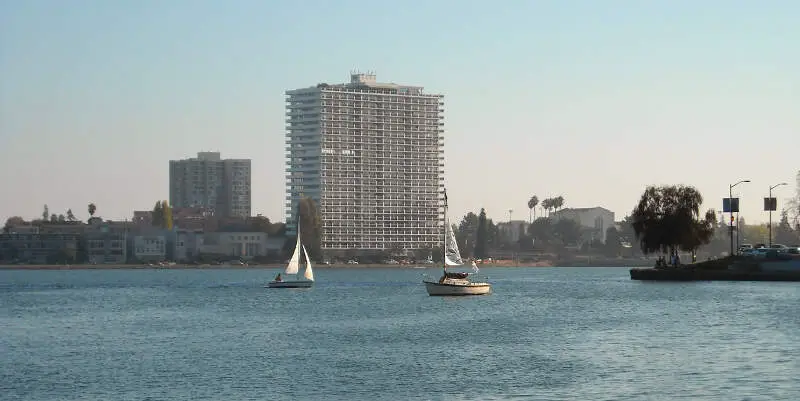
286,74,444,250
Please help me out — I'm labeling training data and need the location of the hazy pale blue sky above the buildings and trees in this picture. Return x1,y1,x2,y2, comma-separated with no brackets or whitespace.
0,0,800,223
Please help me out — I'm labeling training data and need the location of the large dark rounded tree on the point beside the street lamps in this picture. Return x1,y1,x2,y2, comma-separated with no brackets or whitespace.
631,185,716,255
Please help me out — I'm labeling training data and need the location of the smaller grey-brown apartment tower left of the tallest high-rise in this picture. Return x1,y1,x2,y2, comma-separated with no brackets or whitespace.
169,152,252,217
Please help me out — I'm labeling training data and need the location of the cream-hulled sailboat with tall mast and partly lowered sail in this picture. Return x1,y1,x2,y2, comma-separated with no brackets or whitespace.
423,192,492,295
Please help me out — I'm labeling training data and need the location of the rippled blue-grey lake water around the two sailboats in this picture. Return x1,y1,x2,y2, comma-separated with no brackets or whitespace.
0,268,800,401
